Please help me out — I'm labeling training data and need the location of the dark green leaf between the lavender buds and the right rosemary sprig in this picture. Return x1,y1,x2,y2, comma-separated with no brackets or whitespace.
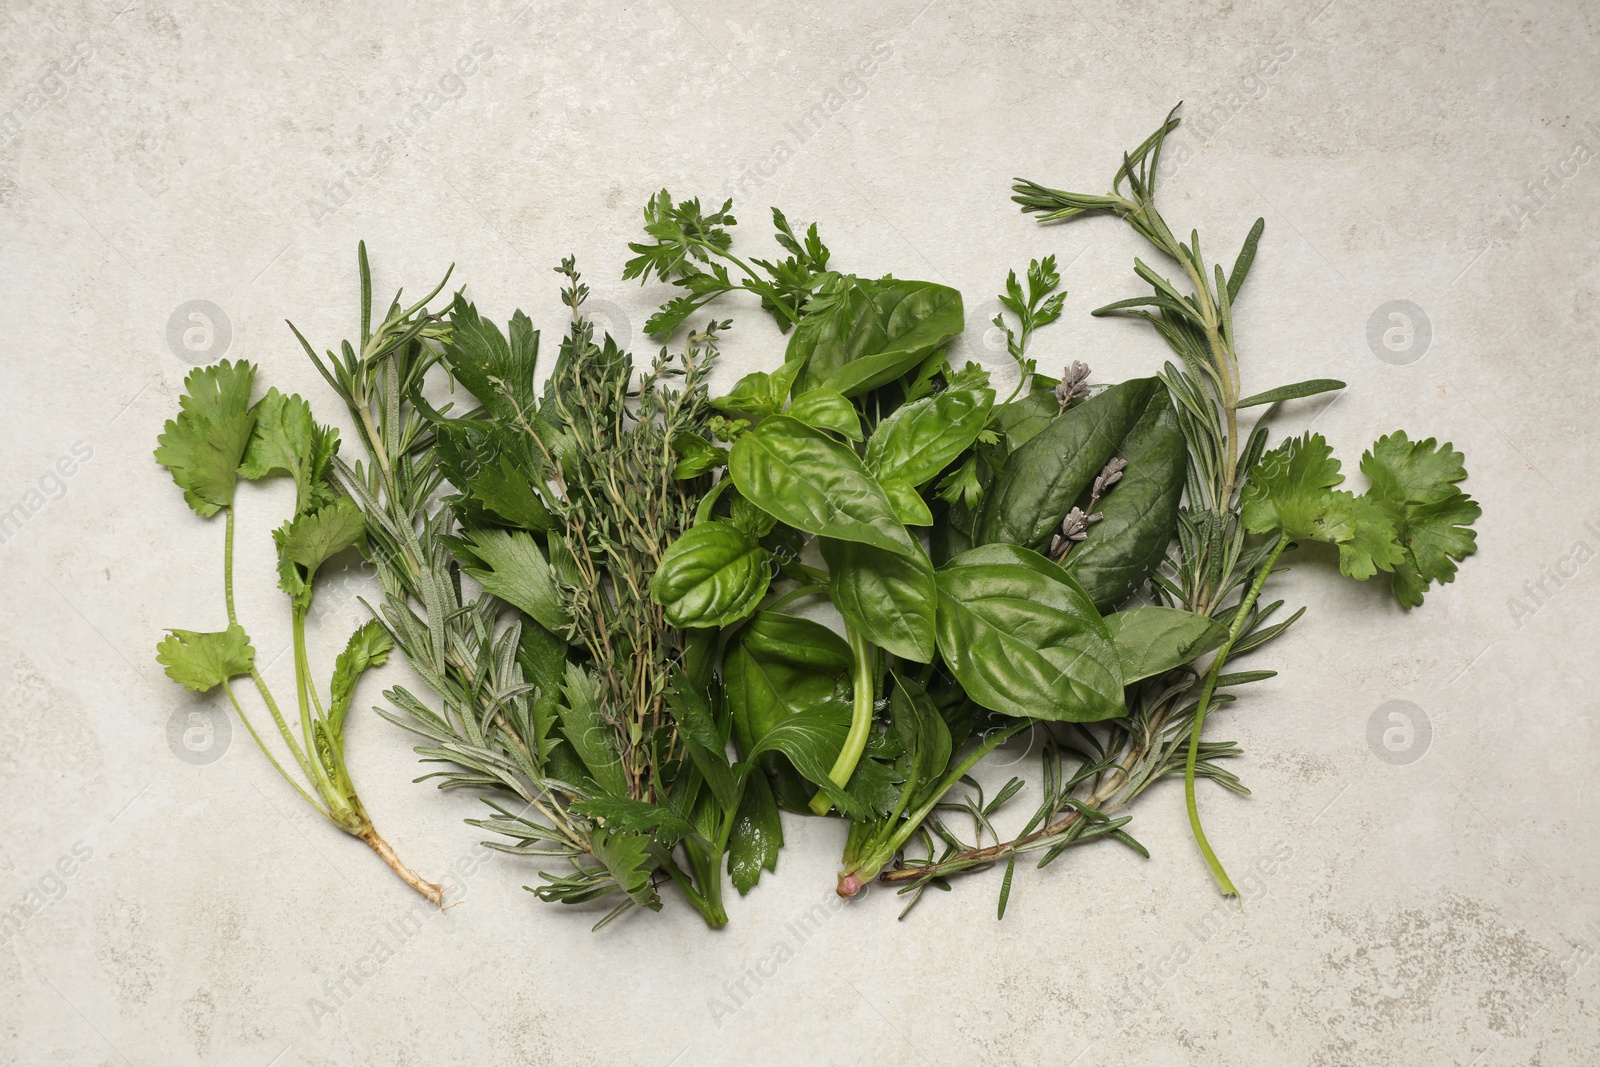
1066,389,1189,611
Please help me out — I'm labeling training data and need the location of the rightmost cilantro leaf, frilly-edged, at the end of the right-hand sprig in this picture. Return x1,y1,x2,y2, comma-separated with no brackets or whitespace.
1362,432,1483,608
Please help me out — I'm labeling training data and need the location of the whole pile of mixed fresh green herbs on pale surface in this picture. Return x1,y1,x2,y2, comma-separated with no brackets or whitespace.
157,106,1478,926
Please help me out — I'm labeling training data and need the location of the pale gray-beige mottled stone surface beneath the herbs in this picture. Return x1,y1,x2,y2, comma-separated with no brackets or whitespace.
0,0,1600,1067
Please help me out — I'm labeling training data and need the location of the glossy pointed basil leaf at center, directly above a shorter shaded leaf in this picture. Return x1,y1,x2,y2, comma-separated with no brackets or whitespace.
728,414,922,555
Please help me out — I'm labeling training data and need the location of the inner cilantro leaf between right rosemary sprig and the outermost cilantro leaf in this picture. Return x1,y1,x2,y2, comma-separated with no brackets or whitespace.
1240,434,1405,581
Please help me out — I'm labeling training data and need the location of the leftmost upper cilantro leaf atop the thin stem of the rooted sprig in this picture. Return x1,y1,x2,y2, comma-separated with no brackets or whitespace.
155,360,256,518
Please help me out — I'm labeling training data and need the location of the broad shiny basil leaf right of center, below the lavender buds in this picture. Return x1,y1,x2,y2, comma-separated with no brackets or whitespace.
938,544,1123,721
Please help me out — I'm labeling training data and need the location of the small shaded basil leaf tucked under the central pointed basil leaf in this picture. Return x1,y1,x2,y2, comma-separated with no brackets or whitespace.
821,537,939,664
